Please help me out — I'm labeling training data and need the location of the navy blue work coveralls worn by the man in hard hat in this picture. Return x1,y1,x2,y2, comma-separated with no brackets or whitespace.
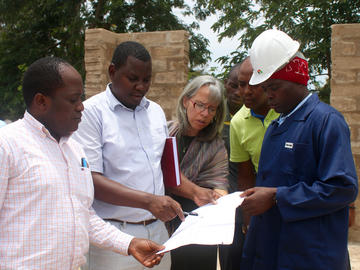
241,94,358,270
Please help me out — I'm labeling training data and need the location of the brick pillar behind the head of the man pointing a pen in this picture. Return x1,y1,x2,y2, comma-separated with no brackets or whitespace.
85,28,189,120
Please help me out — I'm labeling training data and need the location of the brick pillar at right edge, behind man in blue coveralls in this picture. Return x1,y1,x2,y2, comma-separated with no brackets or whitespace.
330,24,360,242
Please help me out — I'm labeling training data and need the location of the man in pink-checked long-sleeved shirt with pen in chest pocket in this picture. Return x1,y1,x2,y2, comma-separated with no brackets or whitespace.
0,57,162,270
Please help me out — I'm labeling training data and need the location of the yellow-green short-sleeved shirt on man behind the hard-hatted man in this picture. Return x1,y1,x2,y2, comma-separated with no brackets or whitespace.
230,106,279,172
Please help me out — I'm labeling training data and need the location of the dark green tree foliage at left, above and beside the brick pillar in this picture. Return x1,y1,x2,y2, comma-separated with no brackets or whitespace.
0,0,210,119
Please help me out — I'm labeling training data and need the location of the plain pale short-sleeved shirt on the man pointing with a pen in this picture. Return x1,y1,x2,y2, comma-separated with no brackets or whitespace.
74,85,167,222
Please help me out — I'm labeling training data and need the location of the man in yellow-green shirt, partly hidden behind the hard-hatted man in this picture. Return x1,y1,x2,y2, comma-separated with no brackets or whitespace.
230,58,279,228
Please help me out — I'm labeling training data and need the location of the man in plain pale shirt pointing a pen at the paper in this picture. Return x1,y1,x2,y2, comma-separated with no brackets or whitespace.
74,41,219,270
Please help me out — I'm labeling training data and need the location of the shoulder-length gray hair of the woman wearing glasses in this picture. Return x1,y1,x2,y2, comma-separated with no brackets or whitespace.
177,75,226,141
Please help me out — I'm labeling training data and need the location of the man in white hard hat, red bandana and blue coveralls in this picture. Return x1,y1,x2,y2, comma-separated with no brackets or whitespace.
241,30,358,270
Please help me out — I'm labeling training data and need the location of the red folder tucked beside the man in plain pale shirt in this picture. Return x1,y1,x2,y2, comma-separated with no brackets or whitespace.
161,137,180,187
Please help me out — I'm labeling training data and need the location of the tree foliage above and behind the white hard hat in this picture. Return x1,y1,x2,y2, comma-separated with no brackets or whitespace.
195,0,360,90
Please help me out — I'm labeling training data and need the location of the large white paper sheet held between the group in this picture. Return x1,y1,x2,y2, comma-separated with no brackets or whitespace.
158,192,244,253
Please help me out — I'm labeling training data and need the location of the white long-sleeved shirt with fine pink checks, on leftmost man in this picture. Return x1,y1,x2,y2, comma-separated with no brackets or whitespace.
0,112,133,270
